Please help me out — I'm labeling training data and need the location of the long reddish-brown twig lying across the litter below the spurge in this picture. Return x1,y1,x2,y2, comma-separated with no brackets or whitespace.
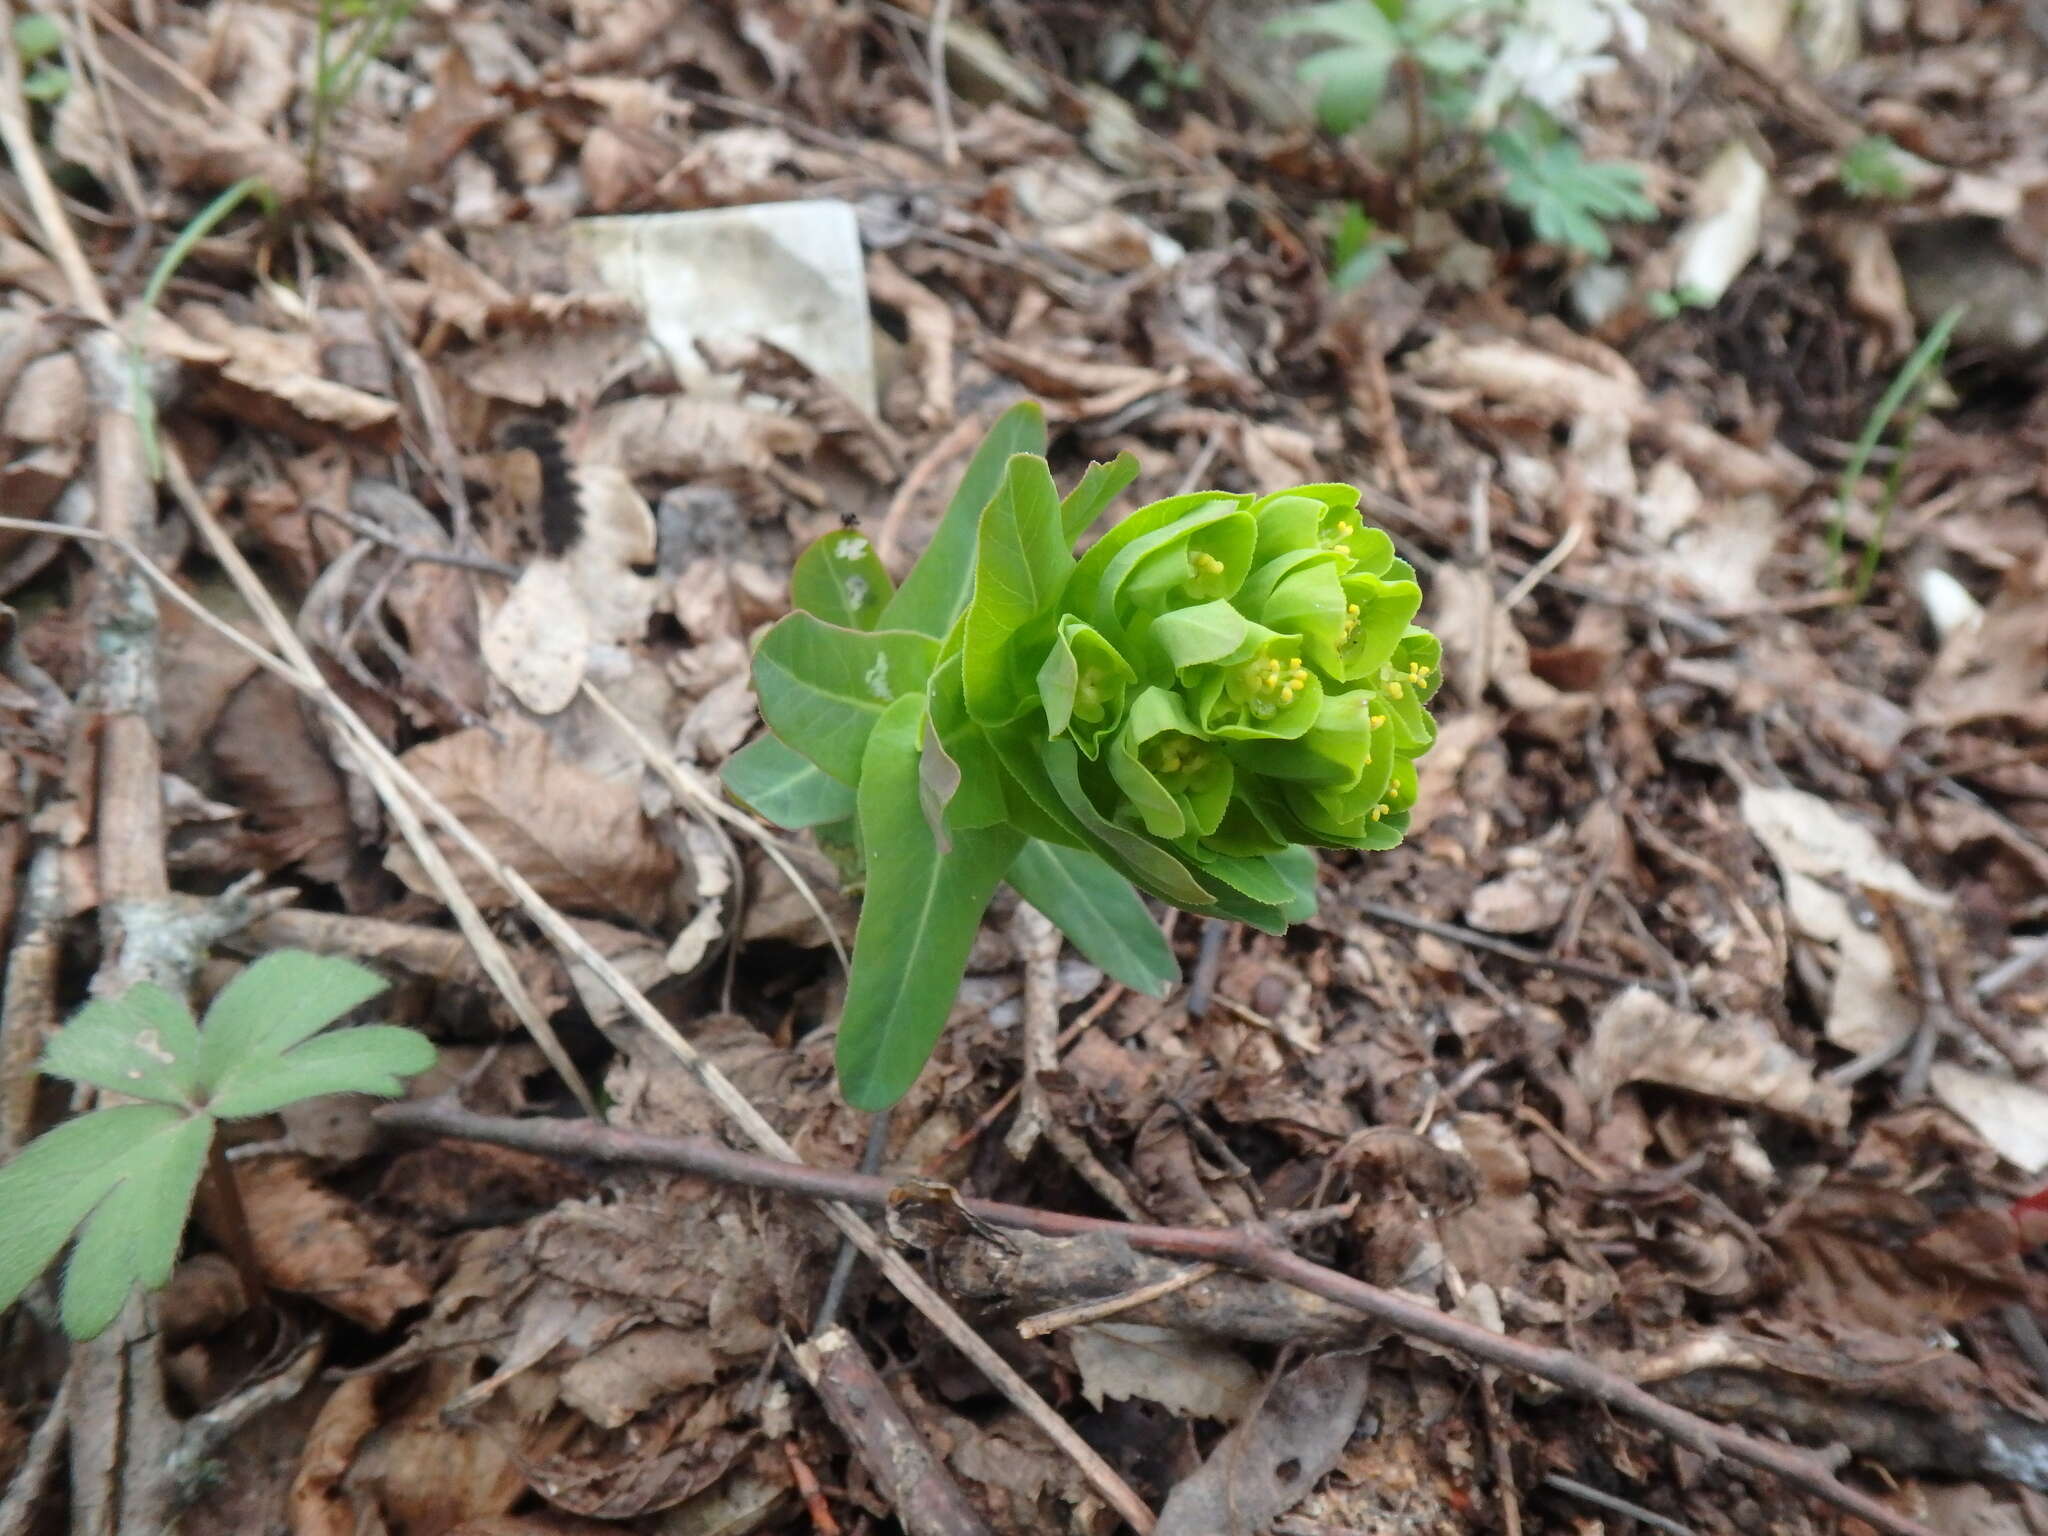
375,1100,1933,1536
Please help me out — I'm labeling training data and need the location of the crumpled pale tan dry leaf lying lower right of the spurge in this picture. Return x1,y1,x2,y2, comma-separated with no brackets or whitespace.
1575,987,1849,1130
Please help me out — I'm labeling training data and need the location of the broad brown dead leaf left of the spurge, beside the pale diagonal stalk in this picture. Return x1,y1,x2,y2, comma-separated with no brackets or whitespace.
385,717,676,928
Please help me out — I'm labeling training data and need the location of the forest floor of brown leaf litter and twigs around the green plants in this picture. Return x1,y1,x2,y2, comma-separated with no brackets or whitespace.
0,0,2048,1536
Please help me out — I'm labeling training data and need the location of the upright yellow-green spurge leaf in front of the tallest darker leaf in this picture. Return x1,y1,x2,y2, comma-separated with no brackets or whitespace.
961,453,1073,725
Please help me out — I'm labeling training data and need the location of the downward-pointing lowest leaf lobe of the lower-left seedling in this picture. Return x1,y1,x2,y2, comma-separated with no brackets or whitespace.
57,1110,213,1339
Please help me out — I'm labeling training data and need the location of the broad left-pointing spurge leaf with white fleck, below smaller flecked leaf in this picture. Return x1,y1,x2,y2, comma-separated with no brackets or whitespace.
754,612,938,784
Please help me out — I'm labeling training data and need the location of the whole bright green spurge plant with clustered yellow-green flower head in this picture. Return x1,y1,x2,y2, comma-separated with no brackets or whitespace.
725,406,1442,1110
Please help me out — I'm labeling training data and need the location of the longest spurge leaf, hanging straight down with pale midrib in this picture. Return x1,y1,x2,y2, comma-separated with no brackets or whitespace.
838,696,1022,1110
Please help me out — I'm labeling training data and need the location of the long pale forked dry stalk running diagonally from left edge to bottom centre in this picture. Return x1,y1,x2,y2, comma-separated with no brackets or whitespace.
24,501,1155,1536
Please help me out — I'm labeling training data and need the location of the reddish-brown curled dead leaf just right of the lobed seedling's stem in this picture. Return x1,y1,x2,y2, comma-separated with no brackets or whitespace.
236,1157,432,1333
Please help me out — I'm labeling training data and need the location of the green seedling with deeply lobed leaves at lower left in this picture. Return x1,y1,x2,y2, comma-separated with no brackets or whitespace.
0,950,434,1339
